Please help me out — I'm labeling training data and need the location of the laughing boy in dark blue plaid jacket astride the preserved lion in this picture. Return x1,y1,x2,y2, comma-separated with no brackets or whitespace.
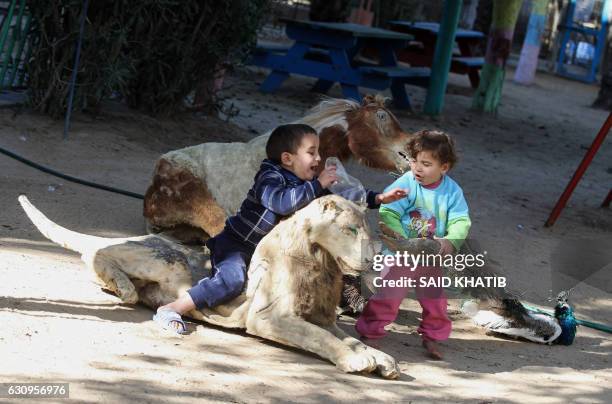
153,124,406,334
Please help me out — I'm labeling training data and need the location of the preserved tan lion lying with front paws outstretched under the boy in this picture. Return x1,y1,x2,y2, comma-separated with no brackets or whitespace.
19,195,440,379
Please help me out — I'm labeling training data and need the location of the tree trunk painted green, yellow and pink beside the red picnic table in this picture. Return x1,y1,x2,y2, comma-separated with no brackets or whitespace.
472,0,523,112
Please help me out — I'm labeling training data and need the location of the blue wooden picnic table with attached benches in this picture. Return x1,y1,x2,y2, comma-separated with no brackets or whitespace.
250,19,430,108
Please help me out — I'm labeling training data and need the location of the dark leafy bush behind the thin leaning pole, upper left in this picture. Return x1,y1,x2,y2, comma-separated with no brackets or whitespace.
27,0,267,117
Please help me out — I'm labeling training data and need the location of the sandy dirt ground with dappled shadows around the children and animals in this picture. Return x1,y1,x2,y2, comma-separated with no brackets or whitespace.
0,59,612,403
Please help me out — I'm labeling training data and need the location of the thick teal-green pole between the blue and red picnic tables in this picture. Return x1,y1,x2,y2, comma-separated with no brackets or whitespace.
423,0,462,115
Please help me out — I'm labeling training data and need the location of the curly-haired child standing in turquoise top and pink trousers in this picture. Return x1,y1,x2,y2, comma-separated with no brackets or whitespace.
355,130,471,359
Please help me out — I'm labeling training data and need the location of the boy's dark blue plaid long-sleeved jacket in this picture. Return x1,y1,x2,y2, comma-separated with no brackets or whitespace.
223,159,378,248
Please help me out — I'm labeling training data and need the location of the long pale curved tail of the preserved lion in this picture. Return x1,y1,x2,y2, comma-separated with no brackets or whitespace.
19,195,125,254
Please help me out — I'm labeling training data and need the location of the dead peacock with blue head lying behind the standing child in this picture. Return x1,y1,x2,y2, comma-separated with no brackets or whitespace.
380,223,576,345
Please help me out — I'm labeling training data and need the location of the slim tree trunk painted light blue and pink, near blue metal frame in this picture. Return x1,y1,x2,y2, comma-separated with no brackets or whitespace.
514,0,548,85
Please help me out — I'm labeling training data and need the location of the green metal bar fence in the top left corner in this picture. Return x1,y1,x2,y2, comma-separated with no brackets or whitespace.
0,0,33,89
